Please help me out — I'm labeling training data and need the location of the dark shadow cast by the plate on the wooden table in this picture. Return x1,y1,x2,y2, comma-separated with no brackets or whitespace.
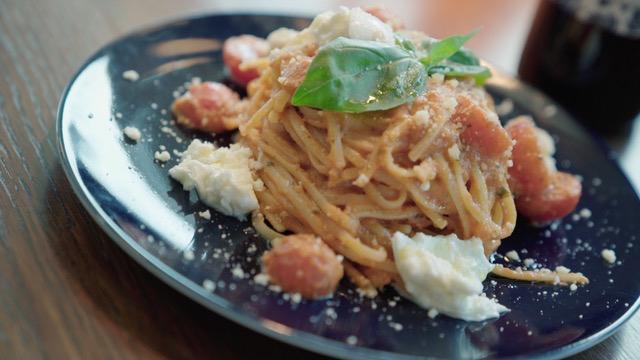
46,165,330,359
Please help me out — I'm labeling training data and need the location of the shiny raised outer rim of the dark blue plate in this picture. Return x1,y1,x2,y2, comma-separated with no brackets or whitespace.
55,11,640,360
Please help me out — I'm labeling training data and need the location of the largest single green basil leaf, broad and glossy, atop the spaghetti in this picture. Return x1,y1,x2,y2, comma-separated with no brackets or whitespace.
291,37,426,113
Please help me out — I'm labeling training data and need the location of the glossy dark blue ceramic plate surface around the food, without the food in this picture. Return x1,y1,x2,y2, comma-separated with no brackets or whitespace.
58,15,640,359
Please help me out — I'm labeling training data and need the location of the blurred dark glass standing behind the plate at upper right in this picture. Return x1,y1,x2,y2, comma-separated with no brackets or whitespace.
518,1,640,134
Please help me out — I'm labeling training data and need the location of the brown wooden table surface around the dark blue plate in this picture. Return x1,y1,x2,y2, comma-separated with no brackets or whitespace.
0,0,640,359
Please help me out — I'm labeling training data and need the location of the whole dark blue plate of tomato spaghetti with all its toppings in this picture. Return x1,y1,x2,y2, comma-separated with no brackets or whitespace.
57,7,640,359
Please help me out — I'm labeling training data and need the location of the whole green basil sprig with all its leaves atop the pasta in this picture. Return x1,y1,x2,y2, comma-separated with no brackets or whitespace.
291,31,491,113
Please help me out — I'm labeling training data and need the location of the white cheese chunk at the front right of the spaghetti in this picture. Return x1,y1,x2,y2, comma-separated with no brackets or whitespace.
392,232,508,321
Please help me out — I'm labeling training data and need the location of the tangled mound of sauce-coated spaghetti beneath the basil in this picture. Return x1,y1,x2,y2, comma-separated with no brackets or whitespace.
238,45,516,288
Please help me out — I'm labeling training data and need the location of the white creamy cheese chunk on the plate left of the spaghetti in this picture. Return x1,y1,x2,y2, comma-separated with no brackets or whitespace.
169,139,258,219
